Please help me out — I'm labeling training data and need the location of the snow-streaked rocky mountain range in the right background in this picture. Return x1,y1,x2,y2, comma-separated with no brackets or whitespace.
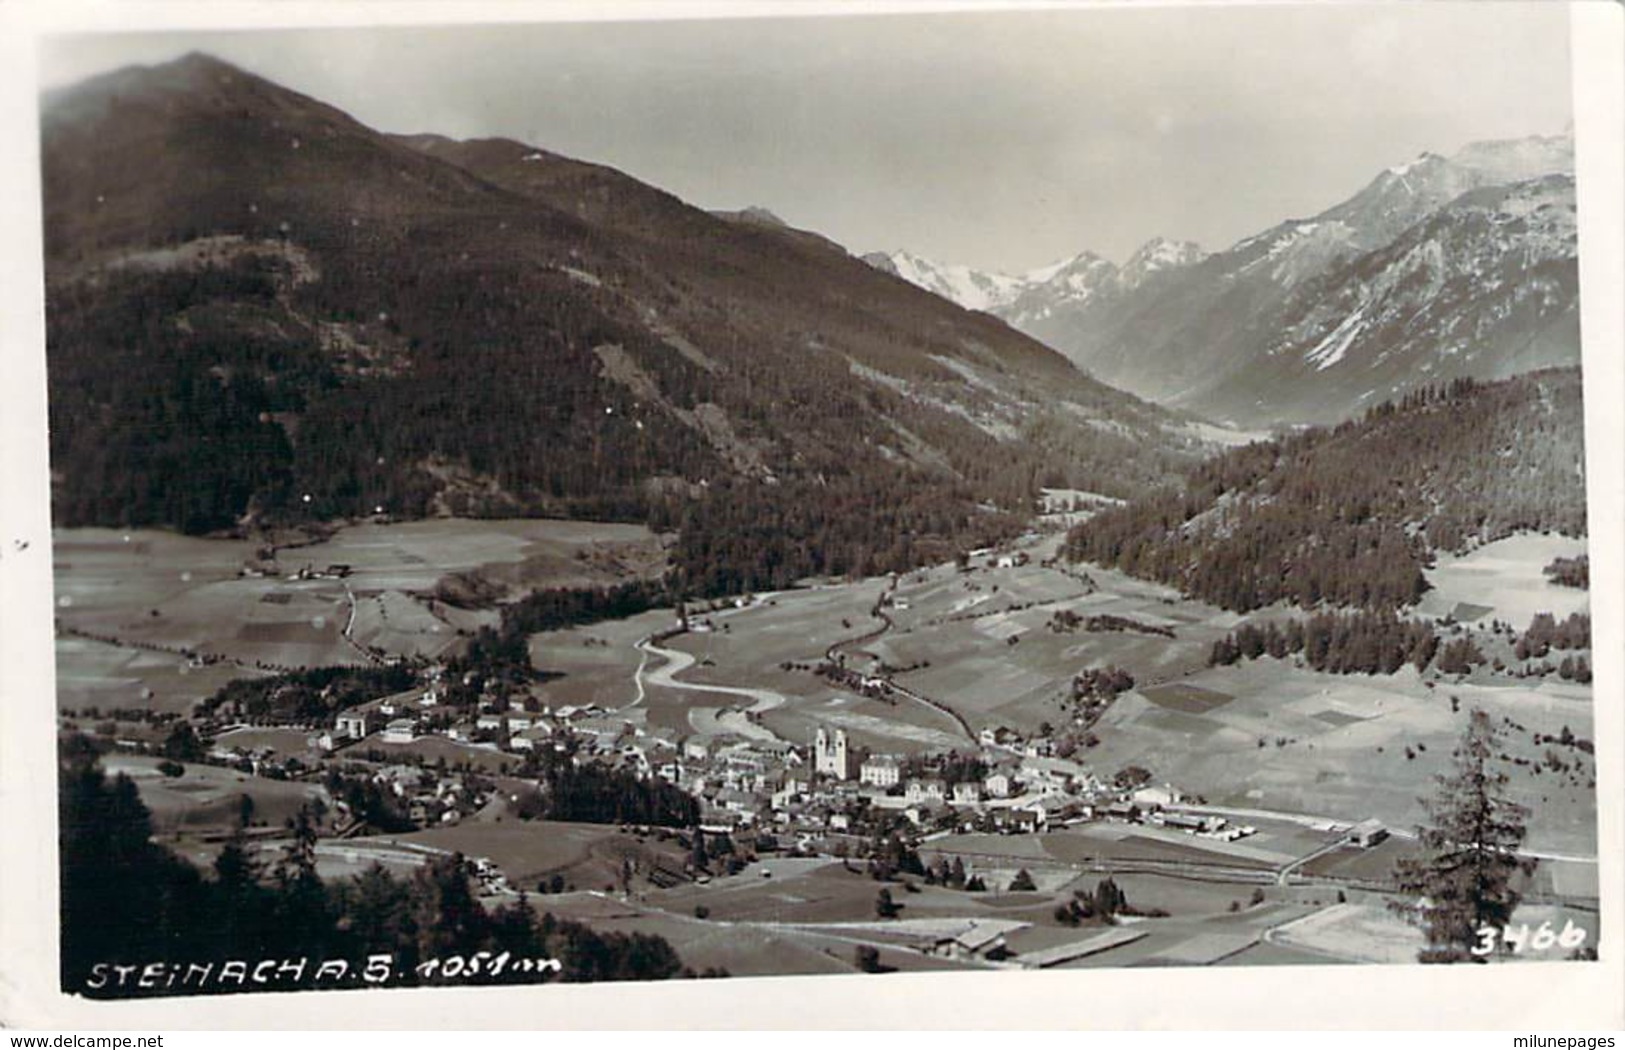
865,132,1580,426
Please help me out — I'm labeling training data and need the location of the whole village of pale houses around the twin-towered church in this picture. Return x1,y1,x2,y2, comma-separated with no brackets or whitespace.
79,640,1386,881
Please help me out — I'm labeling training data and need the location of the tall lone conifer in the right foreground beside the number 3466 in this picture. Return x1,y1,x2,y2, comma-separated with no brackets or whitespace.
1394,709,1534,962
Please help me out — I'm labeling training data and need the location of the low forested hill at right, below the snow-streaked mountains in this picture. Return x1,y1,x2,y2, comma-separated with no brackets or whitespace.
1066,369,1586,611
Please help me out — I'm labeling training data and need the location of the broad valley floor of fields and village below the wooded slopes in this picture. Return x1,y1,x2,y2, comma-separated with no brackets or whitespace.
44,523,1594,975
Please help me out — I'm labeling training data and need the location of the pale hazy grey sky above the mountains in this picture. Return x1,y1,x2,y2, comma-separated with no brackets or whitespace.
41,2,1571,270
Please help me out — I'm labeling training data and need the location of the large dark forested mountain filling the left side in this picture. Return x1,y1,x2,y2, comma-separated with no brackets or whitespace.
42,54,1207,585
